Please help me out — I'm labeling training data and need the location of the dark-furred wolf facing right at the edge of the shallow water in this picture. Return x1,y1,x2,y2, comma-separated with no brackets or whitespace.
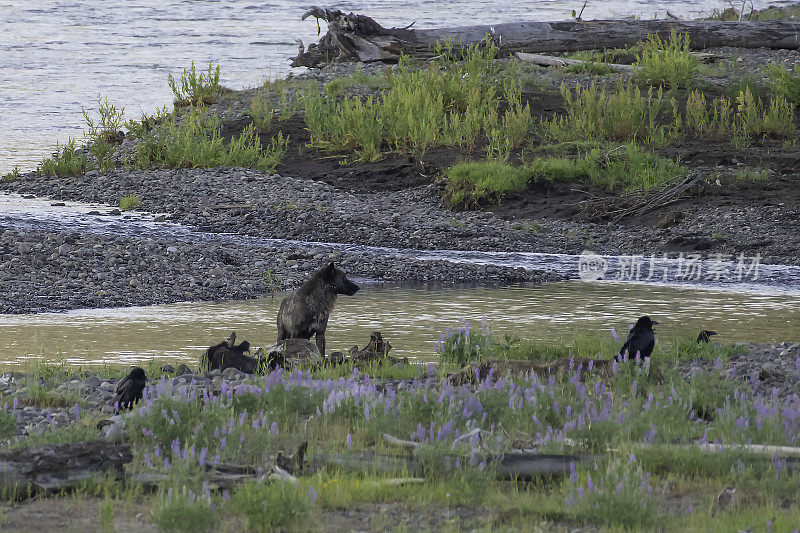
278,263,358,355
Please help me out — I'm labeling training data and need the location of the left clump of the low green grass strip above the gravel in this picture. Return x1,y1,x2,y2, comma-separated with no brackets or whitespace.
445,161,531,209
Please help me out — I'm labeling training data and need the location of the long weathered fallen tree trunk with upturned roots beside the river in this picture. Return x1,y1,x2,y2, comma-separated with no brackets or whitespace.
292,7,800,67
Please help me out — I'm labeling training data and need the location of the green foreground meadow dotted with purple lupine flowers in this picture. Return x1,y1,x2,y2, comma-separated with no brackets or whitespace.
0,324,800,531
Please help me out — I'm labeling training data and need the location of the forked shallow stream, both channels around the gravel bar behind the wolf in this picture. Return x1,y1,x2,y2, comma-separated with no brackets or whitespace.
0,195,800,367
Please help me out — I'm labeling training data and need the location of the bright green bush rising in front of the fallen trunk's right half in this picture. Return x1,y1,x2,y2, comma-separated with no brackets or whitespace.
633,30,700,88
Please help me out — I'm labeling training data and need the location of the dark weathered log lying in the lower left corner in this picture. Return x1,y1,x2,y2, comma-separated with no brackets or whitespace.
0,440,133,497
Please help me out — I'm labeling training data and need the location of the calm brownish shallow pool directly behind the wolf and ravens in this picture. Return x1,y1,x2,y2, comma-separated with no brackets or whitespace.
0,281,800,367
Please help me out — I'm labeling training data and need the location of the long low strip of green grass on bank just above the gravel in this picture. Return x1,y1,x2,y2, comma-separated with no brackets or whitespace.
444,143,686,209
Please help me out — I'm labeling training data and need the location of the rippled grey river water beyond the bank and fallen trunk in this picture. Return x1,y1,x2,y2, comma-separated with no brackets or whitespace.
0,0,790,175
